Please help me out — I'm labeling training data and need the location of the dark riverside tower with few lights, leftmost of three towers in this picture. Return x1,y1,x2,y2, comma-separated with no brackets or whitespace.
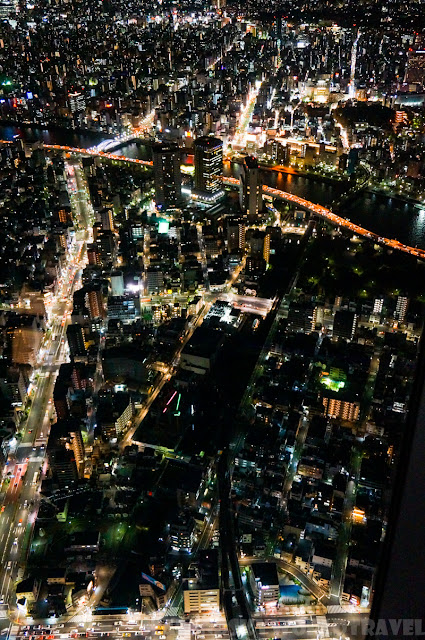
153,142,181,209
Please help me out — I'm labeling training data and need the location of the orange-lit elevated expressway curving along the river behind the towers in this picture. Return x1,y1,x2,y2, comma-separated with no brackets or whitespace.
34,144,425,260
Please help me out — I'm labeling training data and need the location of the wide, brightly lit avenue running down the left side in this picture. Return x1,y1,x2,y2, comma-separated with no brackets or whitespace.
0,160,90,637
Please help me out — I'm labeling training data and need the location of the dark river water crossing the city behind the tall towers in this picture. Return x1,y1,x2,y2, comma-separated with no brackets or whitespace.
0,125,425,249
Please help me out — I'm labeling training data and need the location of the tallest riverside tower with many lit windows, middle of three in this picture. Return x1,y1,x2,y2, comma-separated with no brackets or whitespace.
192,136,224,204
